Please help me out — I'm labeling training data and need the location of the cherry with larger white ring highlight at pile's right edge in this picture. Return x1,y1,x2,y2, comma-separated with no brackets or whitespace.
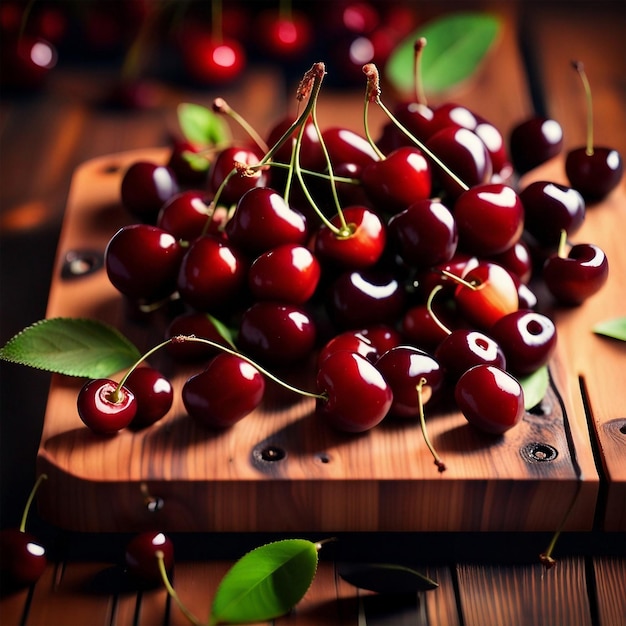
489,309,557,376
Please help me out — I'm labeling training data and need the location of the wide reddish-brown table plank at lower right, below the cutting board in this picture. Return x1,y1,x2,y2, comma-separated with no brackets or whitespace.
457,557,593,626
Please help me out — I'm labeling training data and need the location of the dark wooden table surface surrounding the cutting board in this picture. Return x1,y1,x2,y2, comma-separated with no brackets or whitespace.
0,2,626,626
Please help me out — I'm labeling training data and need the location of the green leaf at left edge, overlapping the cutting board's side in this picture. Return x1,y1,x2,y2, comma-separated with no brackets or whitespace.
0,317,141,378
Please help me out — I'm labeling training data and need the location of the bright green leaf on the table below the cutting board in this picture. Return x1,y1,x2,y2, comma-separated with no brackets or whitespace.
210,539,318,626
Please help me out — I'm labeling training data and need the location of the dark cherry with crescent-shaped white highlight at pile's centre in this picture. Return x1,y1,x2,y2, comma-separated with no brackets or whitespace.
326,270,405,330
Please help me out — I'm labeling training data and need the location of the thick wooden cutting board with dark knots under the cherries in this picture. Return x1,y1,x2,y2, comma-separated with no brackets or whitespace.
38,149,626,532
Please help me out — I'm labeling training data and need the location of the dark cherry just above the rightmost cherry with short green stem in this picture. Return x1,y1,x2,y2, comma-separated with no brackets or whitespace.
519,180,586,248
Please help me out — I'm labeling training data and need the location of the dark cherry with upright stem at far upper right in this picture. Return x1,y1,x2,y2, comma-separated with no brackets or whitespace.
565,61,624,201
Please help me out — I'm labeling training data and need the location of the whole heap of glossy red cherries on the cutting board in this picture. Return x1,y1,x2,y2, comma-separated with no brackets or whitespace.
78,63,622,448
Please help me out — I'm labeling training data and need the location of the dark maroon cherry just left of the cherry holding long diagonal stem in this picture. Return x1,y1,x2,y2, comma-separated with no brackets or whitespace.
387,199,459,269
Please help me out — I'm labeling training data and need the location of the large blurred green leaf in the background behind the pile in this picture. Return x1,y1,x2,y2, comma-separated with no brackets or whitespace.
385,12,501,93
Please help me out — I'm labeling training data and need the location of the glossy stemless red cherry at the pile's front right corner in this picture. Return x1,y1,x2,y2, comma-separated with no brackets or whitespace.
454,365,525,435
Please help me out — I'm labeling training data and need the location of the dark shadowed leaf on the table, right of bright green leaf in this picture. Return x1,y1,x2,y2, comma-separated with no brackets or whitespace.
339,563,439,594
